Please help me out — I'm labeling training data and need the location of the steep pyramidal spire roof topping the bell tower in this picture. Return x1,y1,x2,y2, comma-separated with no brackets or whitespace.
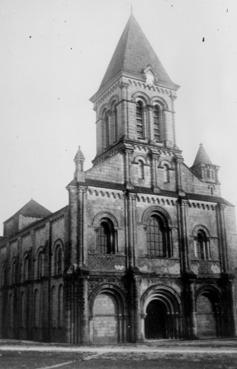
100,15,178,89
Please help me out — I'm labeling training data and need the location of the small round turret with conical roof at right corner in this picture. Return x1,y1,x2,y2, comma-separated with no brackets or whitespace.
190,144,219,184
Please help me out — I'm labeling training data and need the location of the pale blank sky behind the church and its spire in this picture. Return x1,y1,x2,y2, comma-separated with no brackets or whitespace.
0,0,237,233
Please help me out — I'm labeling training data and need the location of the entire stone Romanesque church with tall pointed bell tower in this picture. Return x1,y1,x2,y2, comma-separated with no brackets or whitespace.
0,15,236,344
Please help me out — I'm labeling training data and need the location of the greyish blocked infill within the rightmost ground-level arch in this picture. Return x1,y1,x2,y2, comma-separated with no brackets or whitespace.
197,293,217,338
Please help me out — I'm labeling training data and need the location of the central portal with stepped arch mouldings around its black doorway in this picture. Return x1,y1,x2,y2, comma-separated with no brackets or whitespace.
143,287,181,340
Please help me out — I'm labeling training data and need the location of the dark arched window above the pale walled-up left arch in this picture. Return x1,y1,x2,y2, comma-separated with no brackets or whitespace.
97,218,116,254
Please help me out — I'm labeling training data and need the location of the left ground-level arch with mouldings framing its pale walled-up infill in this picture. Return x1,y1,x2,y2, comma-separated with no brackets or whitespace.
90,286,125,344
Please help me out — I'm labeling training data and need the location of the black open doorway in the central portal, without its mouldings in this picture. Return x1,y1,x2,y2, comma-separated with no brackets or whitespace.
145,300,168,339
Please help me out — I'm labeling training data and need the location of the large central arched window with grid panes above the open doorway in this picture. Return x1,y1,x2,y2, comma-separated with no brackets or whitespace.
147,215,170,257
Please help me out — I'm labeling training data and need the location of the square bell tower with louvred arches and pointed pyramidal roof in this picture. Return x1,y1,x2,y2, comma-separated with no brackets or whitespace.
91,15,179,162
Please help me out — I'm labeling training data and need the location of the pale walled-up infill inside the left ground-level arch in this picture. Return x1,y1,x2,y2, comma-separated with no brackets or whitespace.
92,292,120,344
